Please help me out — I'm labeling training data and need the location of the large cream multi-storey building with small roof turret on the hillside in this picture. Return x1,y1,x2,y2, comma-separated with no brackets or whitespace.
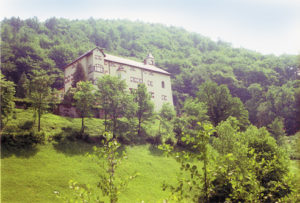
64,47,173,111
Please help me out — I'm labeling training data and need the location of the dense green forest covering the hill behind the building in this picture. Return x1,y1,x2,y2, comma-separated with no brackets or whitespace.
1,17,300,135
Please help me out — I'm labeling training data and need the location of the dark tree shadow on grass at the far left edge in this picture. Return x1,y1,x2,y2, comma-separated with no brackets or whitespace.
1,143,39,159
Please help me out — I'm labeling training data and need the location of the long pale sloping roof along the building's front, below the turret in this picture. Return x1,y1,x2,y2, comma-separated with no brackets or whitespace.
104,54,170,75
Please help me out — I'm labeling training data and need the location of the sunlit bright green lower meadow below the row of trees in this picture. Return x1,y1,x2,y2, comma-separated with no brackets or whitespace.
1,142,179,202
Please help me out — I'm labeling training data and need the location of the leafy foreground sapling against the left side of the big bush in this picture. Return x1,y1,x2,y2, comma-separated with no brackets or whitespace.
159,123,214,202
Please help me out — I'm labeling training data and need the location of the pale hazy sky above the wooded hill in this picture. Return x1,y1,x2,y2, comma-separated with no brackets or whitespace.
0,0,300,55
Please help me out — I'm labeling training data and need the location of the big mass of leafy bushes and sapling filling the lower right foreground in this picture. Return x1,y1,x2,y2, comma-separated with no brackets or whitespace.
160,117,295,202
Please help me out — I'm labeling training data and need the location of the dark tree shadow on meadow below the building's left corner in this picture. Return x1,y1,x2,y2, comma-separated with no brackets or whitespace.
53,139,95,156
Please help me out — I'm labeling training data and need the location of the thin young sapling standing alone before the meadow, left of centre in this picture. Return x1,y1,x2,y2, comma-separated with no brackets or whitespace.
57,132,136,203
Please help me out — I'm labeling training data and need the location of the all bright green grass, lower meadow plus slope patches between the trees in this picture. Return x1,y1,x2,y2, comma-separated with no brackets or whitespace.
1,109,179,203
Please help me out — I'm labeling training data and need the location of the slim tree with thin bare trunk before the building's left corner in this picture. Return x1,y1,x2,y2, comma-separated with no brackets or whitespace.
74,81,95,134
